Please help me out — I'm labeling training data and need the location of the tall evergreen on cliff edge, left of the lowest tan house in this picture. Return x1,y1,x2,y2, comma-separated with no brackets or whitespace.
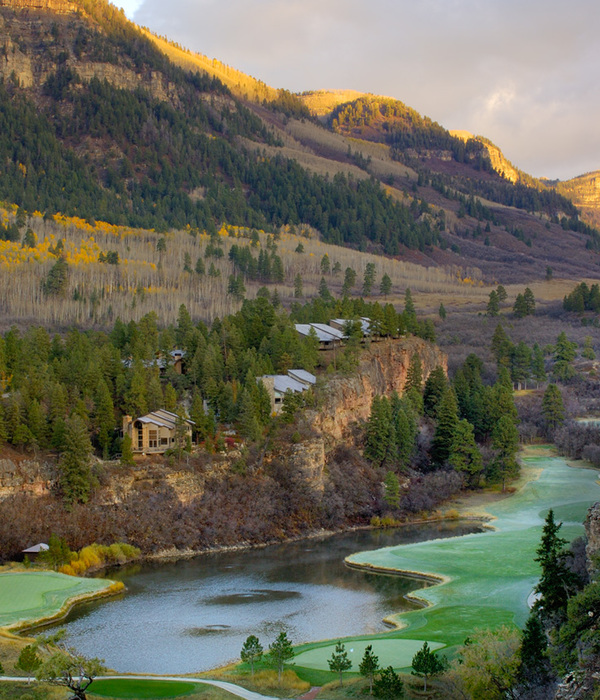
58,415,94,505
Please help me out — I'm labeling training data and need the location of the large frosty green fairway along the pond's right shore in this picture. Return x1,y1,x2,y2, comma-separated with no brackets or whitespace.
294,448,600,671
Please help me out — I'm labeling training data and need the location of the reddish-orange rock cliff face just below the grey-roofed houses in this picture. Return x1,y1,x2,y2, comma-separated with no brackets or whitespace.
309,337,448,443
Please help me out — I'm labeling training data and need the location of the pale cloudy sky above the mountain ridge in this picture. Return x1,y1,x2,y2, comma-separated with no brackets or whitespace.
113,0,600,180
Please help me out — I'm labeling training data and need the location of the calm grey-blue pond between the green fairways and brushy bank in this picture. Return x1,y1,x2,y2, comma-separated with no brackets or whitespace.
60,522,479,674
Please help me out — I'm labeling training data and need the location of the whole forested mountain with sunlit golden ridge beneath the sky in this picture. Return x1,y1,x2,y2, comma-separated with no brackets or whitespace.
0,0,600,280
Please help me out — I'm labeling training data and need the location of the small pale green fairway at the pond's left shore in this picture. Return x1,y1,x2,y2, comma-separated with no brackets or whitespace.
0,571,118,627
